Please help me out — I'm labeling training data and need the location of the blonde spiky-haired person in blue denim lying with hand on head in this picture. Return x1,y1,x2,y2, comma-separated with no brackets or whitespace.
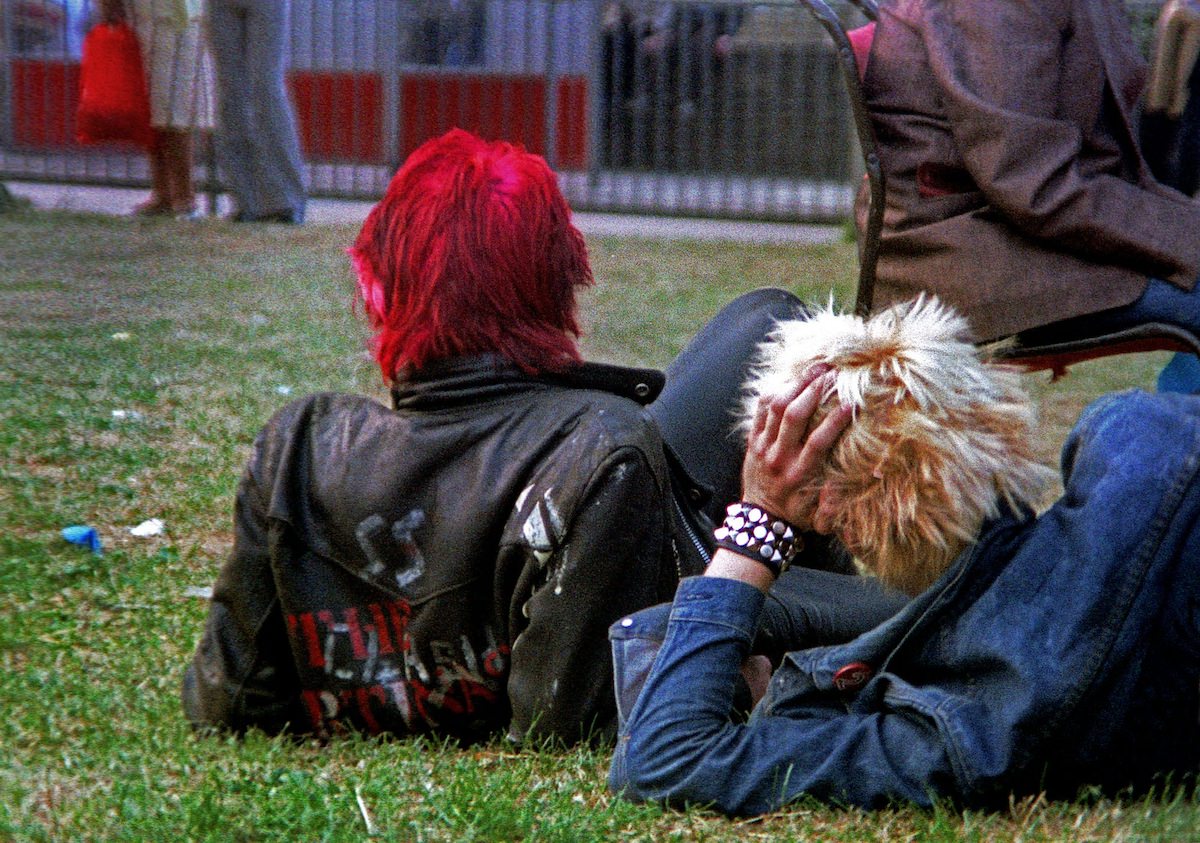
608,299,1200,814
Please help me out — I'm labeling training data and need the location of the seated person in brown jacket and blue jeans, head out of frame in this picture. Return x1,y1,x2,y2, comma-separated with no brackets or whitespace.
864,0,1200,350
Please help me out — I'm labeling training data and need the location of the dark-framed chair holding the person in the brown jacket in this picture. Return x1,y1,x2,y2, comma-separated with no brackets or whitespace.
799,0,1200,378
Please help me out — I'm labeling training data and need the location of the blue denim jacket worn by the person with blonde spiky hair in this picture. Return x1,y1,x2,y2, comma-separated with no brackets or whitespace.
610,393,1200,814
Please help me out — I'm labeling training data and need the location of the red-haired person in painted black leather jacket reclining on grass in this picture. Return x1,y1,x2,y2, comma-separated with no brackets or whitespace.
184,131,844,742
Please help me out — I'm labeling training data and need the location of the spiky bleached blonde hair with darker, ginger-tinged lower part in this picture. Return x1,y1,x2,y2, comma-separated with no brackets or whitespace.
743,295,1054,594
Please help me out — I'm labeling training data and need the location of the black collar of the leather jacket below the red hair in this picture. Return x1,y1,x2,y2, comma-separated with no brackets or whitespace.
391,354,666,409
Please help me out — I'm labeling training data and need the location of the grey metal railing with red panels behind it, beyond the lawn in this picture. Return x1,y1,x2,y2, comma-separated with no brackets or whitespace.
0,0,1157,220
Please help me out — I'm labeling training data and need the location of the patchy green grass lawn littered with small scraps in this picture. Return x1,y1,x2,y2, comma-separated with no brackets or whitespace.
0,207,1200,841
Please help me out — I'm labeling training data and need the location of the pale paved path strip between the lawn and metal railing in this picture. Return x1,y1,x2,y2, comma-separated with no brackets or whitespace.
6,181,842,244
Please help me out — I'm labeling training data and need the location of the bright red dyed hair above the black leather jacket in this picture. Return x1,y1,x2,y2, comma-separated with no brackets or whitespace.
350,130,593,379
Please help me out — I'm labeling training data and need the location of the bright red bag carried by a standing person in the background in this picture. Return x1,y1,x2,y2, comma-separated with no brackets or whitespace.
76,23,151,147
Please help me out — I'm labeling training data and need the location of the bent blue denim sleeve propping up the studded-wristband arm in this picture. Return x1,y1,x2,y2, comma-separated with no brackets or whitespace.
608,578,949,814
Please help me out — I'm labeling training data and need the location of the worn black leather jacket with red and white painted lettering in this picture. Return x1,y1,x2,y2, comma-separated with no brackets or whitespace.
184,358,707,742
